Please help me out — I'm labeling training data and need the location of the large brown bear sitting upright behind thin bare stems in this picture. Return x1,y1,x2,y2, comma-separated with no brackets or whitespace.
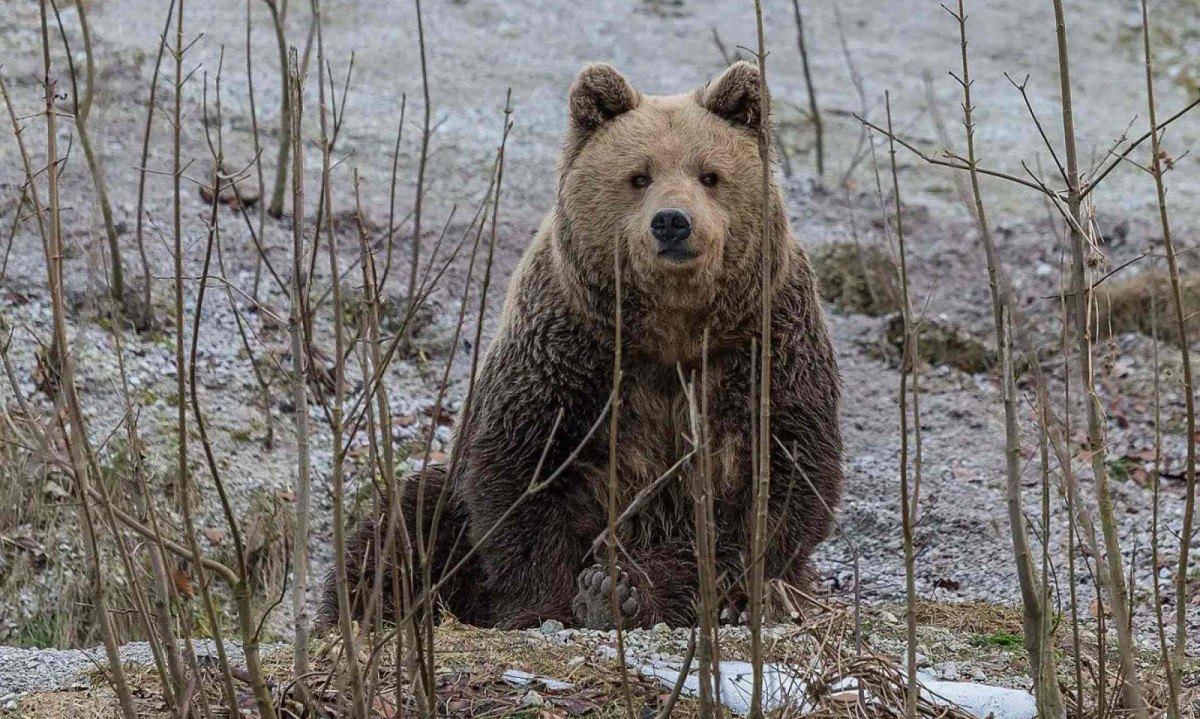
323,62,842,628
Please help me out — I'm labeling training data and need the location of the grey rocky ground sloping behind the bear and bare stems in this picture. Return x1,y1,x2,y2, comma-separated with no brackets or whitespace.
0,0,1200,710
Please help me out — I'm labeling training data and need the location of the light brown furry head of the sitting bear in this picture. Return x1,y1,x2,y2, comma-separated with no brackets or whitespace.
554,62,787,350
